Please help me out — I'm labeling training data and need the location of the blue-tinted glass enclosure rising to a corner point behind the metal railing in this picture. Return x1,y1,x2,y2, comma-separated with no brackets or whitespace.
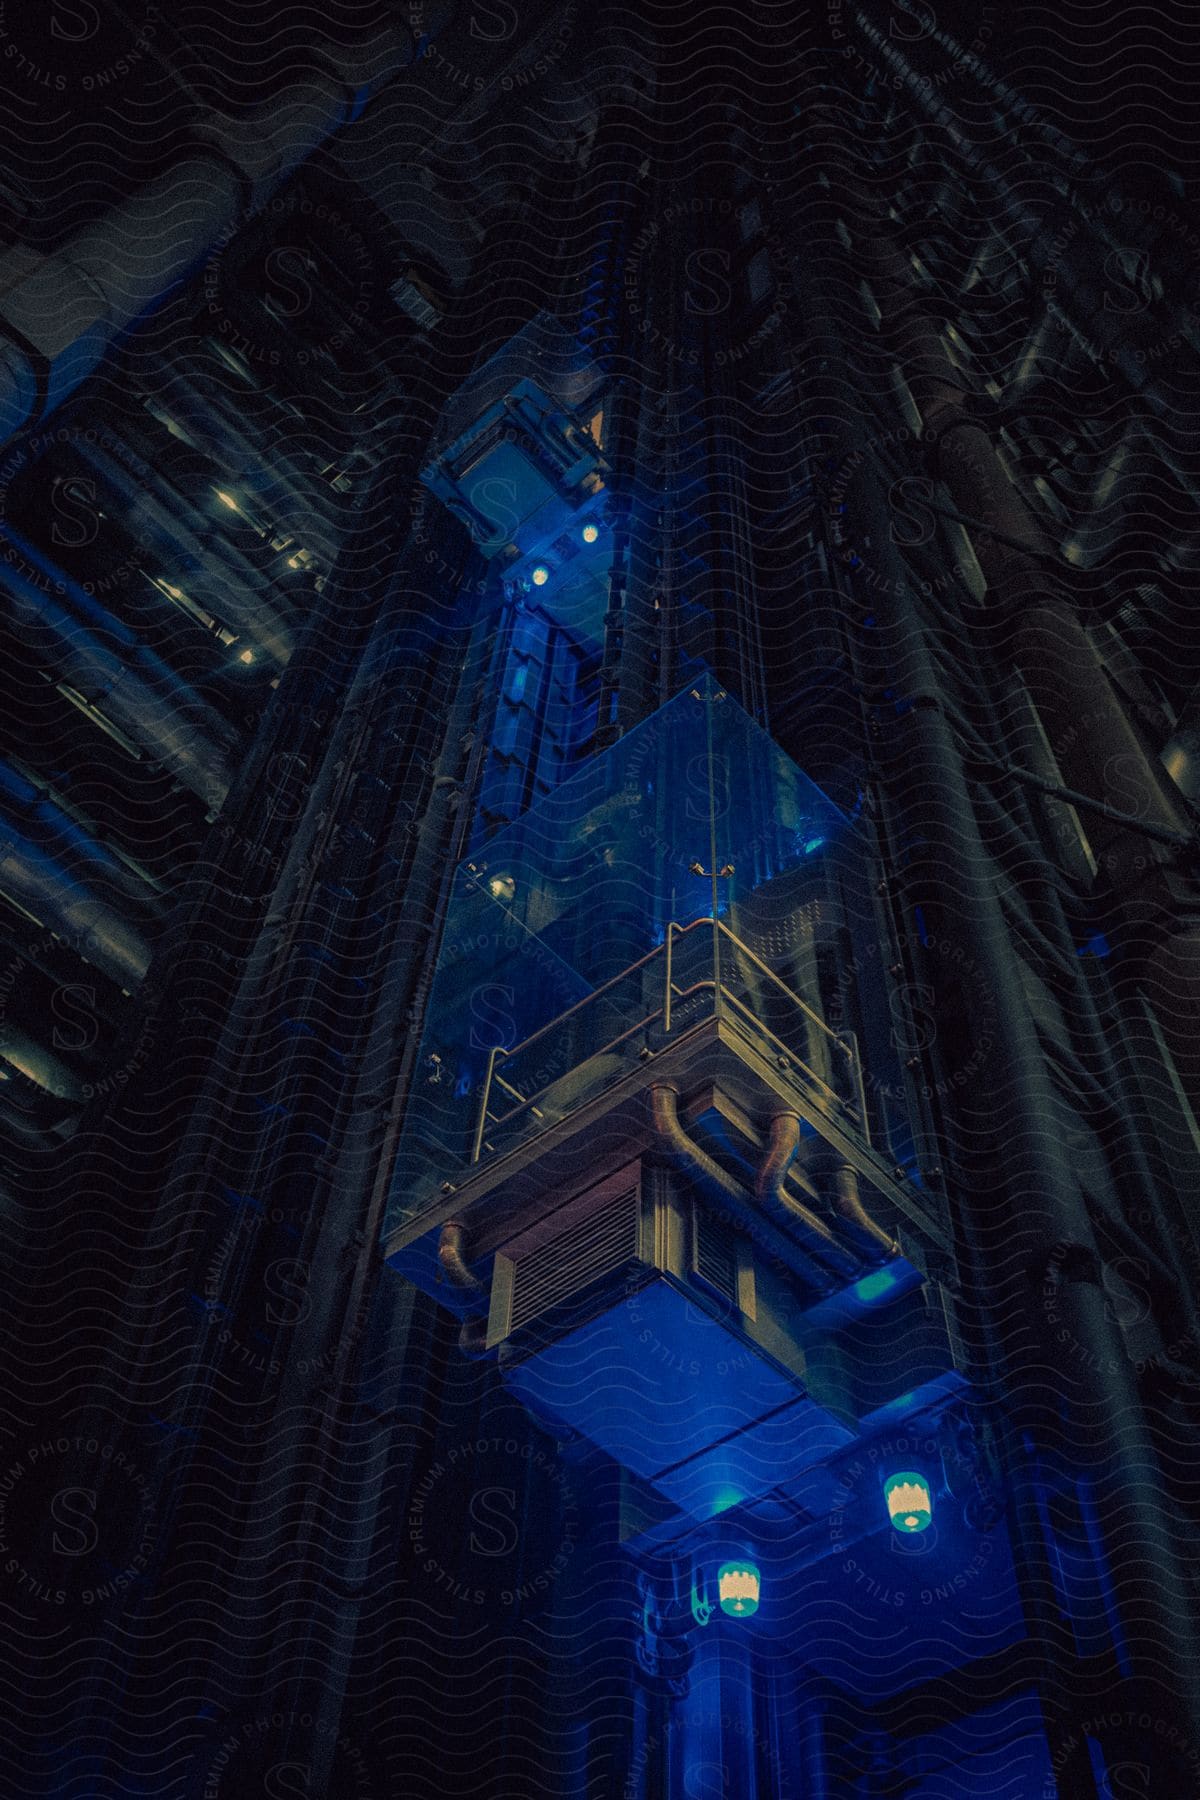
389,677,900,1229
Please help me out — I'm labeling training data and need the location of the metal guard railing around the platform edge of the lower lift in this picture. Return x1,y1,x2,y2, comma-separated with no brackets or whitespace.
471,918,867,1163
